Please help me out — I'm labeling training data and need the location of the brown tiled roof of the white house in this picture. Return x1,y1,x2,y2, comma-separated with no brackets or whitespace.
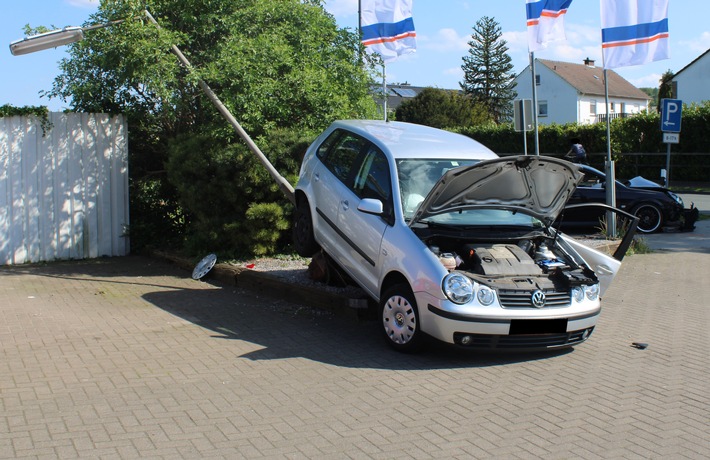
537,59,651,101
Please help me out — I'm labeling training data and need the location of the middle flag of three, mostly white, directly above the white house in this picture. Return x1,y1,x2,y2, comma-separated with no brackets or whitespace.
525,0,572,52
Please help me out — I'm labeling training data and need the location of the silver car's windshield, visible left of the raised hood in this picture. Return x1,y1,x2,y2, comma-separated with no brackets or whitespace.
397,158,479,220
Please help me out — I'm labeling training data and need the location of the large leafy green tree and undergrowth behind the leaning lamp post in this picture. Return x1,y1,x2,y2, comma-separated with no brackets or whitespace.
47,0,375,255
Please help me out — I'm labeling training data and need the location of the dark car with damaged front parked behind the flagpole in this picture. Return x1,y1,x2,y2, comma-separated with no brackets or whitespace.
562,165,697,233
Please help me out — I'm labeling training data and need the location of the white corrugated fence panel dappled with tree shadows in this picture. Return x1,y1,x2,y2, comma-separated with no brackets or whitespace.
0,113,130,265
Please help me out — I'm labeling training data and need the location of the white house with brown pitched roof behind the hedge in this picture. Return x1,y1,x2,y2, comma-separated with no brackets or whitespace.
515,59,650,125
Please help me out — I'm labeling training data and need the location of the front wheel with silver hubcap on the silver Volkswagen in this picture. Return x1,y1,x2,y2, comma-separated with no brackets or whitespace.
380,283,424,353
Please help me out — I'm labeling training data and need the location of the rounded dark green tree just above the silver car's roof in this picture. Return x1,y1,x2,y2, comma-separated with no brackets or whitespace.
395,88,490,128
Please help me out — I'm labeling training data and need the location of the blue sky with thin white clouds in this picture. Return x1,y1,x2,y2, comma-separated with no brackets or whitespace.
0,0,710,111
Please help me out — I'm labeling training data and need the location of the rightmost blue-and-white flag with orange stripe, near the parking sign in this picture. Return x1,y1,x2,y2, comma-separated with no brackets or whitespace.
601,0,670,69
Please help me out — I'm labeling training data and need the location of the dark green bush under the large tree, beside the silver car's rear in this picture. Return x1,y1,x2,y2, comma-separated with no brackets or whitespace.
167,126,314,258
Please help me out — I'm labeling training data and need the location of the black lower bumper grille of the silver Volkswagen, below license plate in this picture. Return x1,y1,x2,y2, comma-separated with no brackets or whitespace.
454,328,594,350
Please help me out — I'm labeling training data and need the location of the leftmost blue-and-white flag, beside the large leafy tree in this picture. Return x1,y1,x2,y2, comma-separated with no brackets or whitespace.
360,0,417,62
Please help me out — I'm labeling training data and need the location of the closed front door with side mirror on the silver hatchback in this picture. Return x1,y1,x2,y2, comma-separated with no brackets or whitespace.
338,144,394,297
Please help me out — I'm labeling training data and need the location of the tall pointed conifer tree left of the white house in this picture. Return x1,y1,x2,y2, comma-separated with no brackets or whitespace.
460,16,517,123
